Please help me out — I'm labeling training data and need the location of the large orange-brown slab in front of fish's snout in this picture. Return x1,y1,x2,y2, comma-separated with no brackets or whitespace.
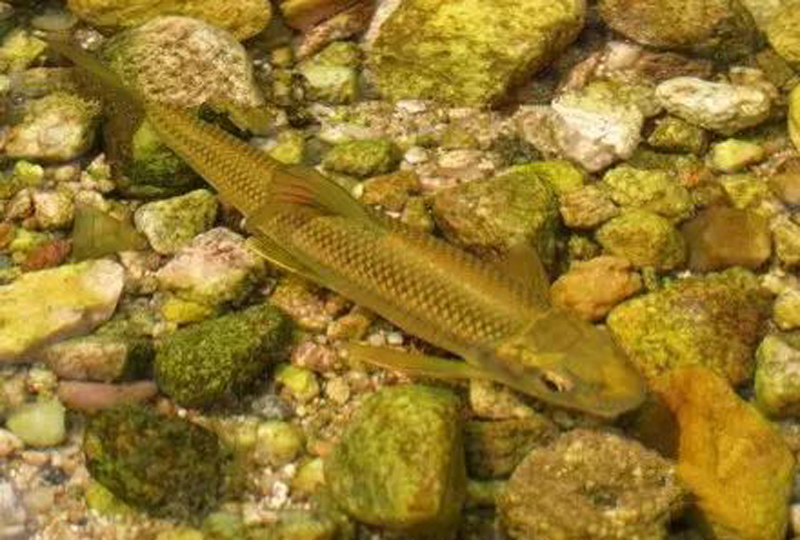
651,366,794,540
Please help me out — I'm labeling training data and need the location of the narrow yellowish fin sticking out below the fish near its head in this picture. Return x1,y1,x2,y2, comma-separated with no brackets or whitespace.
347,344,492,380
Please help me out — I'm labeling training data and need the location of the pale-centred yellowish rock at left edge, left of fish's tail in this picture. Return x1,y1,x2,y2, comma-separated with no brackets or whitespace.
5,92,100,162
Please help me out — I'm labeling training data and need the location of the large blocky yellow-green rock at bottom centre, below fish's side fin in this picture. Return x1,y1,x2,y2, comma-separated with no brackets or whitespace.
325,385,466,539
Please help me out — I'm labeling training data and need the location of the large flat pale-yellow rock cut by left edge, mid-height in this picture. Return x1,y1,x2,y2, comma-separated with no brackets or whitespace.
0,261,124,364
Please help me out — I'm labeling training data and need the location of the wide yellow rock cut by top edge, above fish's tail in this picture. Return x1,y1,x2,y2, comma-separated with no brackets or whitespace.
67,0,272,40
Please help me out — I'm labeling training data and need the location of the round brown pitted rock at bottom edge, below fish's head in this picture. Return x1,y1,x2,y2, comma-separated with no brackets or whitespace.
498,429,684,540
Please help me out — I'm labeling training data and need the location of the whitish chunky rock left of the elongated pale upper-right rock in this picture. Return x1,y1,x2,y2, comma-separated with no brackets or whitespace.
553,81,645,171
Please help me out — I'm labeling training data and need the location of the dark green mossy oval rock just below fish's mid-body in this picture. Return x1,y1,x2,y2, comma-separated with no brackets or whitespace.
154,304,291,407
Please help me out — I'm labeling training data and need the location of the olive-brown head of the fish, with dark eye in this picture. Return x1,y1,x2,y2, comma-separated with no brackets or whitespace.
487,310,646,417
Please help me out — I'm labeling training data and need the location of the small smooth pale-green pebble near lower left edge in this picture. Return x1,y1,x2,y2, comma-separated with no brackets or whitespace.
6,399,67,448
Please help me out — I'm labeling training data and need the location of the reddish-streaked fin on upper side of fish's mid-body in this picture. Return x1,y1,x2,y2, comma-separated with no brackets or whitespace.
257,166,380,226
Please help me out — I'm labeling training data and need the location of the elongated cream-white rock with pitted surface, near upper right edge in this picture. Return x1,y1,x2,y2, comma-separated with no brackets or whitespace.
656,77,772,135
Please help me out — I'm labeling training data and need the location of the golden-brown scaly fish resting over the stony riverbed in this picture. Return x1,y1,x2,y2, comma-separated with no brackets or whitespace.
51,41,646,418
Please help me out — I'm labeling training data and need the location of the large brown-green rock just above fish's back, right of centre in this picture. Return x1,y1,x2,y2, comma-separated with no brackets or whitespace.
432,165,559,264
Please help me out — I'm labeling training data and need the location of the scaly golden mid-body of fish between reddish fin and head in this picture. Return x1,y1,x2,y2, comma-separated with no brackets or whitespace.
273,212,535,356
